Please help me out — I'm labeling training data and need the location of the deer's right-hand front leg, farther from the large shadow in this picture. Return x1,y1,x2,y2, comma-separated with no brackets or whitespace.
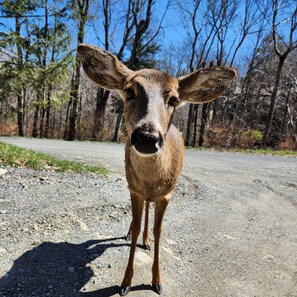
152,194,171,295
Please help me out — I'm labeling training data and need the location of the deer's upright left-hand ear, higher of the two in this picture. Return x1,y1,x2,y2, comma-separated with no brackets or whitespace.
77,44,133,90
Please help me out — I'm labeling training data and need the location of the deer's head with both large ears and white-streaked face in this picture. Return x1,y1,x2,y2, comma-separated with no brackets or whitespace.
78,44,236,157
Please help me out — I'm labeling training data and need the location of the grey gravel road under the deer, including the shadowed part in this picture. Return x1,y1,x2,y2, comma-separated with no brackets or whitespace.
0,137,297,297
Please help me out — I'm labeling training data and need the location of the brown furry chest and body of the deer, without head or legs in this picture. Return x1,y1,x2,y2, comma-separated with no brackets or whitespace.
125,125,184,202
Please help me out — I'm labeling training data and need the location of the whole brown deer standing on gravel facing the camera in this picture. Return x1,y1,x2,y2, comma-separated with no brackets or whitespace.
78,44,236,296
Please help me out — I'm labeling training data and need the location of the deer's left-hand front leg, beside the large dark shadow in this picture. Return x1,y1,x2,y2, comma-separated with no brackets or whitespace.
120,193,144,296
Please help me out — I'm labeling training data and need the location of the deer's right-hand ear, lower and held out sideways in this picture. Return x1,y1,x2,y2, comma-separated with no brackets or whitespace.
178,67,236,103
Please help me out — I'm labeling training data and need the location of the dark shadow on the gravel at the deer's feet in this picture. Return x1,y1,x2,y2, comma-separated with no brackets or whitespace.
0,237,149,297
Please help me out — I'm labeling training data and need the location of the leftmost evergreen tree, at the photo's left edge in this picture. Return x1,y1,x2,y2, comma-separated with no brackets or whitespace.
0,0,38,136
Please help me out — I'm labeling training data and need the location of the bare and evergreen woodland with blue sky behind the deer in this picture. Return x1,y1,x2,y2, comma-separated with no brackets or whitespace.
0,0,297,150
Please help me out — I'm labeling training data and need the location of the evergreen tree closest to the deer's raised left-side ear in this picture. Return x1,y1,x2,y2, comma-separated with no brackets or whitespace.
31,0,71,137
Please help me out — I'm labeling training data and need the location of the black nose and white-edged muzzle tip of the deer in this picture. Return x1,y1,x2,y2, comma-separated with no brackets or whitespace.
131,129,164,154
